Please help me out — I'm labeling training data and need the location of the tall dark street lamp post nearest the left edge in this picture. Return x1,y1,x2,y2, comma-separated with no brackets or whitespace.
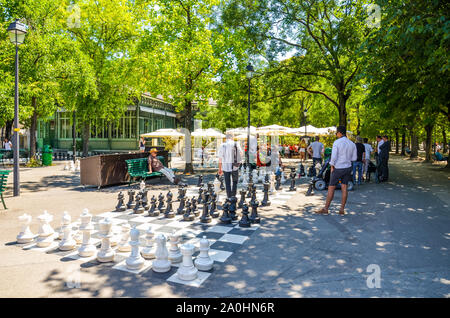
8,19,27,197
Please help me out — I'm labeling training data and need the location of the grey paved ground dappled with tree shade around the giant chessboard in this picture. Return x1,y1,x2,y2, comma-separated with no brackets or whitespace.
0,156,450,297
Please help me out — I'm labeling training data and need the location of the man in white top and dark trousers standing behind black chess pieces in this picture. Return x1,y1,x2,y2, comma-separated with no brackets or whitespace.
218,133,242,198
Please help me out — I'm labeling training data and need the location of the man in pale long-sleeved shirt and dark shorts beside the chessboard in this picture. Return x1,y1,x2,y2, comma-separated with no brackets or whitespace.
316,126,357,215
